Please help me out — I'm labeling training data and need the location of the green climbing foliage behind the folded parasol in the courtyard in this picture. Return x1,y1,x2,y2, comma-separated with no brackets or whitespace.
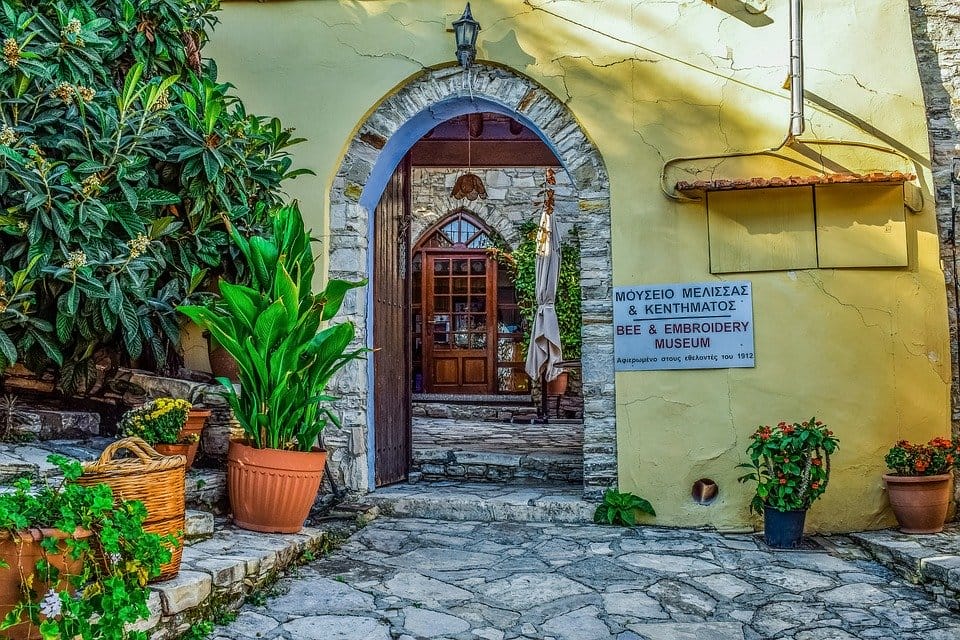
492,222,582,360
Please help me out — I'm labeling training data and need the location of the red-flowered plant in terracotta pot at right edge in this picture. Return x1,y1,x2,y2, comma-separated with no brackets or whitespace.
883,438,960,533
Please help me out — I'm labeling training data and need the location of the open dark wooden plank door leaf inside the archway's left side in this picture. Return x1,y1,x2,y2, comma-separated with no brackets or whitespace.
369,157,412,487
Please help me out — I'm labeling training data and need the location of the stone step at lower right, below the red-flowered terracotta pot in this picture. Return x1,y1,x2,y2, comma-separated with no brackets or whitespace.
850,523,960,611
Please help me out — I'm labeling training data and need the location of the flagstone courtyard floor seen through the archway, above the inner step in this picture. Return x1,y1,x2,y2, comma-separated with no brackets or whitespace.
413,418,583,455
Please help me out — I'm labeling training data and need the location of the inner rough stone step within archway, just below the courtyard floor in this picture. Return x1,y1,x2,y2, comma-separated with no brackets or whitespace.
412,447,583,484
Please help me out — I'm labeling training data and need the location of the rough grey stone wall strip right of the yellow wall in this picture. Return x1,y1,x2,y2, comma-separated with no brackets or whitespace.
910,0,960,437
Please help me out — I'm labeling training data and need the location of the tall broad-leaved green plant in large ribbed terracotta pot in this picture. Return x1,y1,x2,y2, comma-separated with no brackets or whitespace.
180,203,366,533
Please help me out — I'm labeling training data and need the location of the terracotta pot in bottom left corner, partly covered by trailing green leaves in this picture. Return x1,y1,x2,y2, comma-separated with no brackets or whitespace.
0,529,93,640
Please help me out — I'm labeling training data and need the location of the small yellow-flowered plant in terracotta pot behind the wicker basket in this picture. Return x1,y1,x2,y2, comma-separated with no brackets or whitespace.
120,397,205,469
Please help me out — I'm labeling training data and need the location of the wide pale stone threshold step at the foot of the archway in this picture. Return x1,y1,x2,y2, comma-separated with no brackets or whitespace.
363,481,597,522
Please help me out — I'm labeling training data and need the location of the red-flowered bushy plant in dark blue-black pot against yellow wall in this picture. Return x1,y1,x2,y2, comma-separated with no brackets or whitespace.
737,418,840,549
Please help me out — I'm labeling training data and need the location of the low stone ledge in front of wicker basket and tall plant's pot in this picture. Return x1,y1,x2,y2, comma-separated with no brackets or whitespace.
134,523,349,640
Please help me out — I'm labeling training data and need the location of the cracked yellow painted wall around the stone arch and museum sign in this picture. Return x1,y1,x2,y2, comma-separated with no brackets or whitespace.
205,0,950,530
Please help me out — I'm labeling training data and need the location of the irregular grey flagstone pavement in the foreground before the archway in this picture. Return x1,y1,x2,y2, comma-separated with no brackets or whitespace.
217,518,960,640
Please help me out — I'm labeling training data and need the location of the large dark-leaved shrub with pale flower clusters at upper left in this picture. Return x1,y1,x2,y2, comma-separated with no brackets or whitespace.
0,0,310,389
